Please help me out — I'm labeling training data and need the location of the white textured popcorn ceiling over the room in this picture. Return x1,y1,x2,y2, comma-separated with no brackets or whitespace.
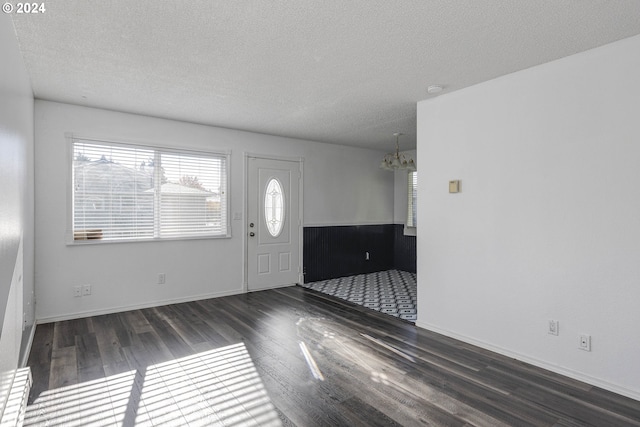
12,0,640,149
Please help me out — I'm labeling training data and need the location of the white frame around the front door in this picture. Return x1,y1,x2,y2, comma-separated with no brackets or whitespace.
241,151,304,293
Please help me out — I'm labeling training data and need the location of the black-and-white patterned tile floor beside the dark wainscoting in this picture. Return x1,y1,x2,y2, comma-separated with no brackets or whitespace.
302,270,417,322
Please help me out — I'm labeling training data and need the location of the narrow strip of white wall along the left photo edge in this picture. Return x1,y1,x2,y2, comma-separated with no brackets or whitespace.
0,14,33,422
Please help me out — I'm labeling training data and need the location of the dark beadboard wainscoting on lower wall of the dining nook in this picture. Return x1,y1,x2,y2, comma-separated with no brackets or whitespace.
303,224,416,283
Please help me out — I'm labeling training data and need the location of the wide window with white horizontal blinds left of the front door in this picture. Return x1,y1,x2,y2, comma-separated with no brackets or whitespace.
71,139,228,241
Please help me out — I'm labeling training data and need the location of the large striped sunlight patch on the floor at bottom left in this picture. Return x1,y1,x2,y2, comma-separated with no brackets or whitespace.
25,343,282,427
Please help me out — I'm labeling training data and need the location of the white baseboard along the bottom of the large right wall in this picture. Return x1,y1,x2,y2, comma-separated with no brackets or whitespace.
415,321,640,400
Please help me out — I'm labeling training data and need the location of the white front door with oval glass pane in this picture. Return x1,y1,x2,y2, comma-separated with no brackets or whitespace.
246,157,302,291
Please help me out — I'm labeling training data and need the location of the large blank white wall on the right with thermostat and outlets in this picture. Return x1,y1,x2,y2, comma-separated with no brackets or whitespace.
417,36,640,399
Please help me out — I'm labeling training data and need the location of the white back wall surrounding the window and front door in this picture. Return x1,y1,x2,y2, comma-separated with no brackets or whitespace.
35,101,393,321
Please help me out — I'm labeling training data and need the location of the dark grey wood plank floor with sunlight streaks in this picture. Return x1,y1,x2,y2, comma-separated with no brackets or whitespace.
25,287,640,427
